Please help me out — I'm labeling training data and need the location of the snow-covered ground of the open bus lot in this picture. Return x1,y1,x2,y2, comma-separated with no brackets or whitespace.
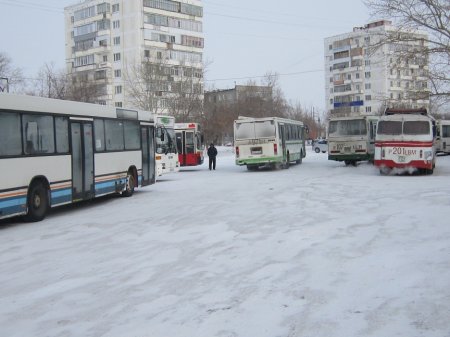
0,148,450,337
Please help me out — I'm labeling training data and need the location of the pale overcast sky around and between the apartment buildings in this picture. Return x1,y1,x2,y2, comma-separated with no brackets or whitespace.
0,0,371,110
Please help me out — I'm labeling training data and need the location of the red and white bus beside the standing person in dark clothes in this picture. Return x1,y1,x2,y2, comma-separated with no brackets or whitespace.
175,123,205,166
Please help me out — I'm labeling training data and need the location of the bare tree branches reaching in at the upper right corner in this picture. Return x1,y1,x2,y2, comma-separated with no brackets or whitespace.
364,0,450,102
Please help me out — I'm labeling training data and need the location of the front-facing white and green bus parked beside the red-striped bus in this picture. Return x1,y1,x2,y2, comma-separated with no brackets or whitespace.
328,115,380,165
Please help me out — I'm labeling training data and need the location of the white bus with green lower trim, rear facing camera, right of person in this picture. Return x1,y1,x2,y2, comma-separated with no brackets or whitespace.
234,117,306,170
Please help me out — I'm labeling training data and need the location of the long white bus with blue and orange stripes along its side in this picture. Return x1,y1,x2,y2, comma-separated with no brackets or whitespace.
0,94,155,221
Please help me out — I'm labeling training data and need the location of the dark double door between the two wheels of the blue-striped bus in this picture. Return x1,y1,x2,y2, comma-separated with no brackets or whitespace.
70,121,95,201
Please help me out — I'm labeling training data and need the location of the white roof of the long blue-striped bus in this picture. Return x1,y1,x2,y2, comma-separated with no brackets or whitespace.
0,94,153,122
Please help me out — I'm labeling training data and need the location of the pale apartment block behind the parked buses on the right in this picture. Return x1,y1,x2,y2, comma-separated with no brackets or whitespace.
324,20,429,115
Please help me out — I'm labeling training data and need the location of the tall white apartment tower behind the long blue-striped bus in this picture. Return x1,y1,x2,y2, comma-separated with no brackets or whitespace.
65,0,204,113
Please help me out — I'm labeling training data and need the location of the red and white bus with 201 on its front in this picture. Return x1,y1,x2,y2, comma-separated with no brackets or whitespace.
375,109,436,174
